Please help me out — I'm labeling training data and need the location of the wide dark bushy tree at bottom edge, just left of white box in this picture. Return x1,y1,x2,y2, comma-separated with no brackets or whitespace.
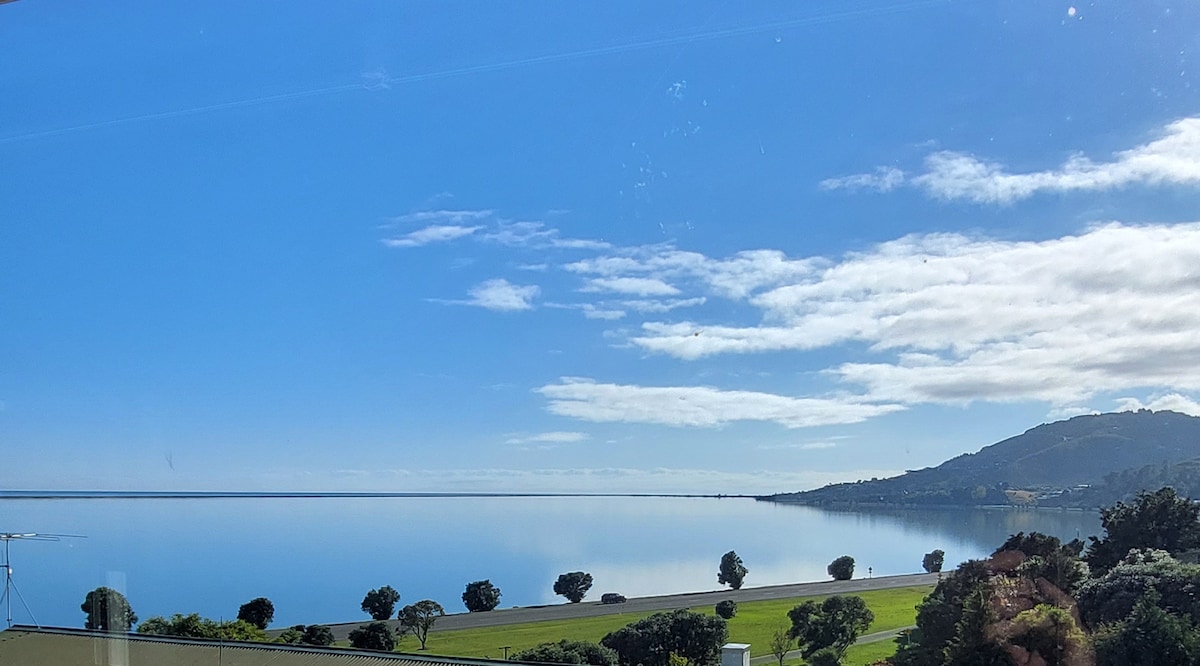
600,610,728,666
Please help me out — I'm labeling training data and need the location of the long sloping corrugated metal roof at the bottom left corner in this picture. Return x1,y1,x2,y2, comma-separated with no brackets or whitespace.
0,626,530,666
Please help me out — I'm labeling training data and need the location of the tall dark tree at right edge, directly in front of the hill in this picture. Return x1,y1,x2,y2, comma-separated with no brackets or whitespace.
1085,488,1200,572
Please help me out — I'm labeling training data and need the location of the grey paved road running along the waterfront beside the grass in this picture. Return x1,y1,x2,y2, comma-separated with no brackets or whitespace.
319,574,938,641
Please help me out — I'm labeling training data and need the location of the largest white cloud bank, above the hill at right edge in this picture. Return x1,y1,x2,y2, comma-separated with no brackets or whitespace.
632,223,1200,406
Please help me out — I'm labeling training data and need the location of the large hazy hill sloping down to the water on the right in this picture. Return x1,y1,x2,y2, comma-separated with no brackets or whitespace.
761,409,1200,506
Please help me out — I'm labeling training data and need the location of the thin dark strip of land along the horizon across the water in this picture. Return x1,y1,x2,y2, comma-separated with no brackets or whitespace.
0,491,756,499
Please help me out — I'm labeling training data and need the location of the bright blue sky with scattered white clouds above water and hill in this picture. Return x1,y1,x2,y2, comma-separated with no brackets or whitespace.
0,0,1200,493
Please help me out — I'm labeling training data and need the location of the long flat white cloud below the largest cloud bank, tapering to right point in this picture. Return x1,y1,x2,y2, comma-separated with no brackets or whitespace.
536,377,904,428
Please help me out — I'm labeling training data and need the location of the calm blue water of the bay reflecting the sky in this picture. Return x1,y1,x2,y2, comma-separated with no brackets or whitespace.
0,497,1099,626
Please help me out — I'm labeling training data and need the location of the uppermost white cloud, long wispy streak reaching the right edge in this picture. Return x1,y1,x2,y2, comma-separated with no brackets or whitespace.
821,118,1200,204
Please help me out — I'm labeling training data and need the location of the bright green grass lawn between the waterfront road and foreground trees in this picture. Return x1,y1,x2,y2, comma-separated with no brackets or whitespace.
417,586,932,666
